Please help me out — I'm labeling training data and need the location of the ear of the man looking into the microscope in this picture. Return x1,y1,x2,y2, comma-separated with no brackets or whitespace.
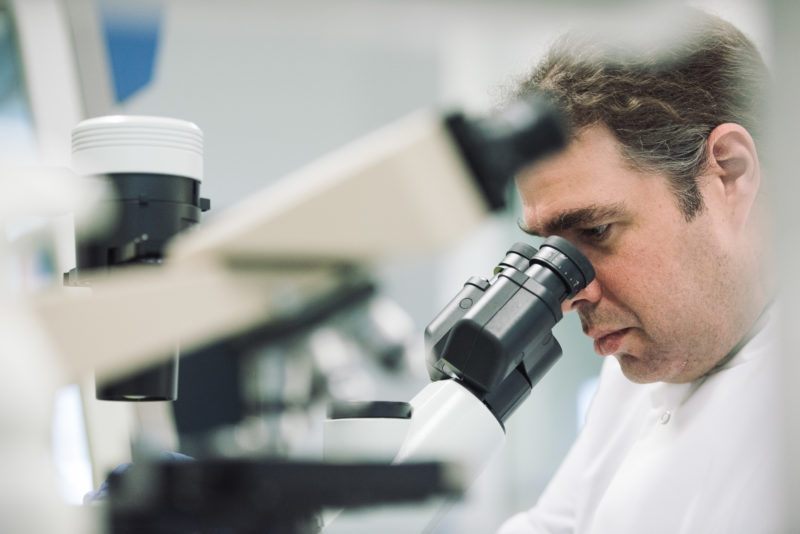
705,123,761,227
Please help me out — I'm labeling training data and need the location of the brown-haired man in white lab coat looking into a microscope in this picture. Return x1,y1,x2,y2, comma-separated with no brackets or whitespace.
499,11,785,534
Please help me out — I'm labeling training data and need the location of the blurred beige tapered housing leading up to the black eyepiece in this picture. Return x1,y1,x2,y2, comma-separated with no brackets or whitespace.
167,112,489,263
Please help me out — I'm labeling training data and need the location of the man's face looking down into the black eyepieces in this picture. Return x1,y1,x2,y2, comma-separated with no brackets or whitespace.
517,126,743,383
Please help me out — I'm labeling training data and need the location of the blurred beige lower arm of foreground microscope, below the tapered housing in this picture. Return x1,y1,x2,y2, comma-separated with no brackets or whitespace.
32,263,342,383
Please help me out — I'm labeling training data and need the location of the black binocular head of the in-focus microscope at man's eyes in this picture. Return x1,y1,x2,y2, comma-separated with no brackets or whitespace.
425,236,594,421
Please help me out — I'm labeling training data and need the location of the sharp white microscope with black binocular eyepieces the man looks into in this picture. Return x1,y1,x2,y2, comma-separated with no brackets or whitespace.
324,240,594,533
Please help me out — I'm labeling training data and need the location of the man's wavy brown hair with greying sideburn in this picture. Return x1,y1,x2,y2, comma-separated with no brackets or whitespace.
515,9,769,220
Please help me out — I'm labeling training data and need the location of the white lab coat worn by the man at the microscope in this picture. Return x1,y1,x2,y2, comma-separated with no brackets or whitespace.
498,311,786,534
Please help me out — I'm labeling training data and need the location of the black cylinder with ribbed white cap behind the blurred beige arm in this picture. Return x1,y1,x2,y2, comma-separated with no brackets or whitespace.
64,116,211,401
